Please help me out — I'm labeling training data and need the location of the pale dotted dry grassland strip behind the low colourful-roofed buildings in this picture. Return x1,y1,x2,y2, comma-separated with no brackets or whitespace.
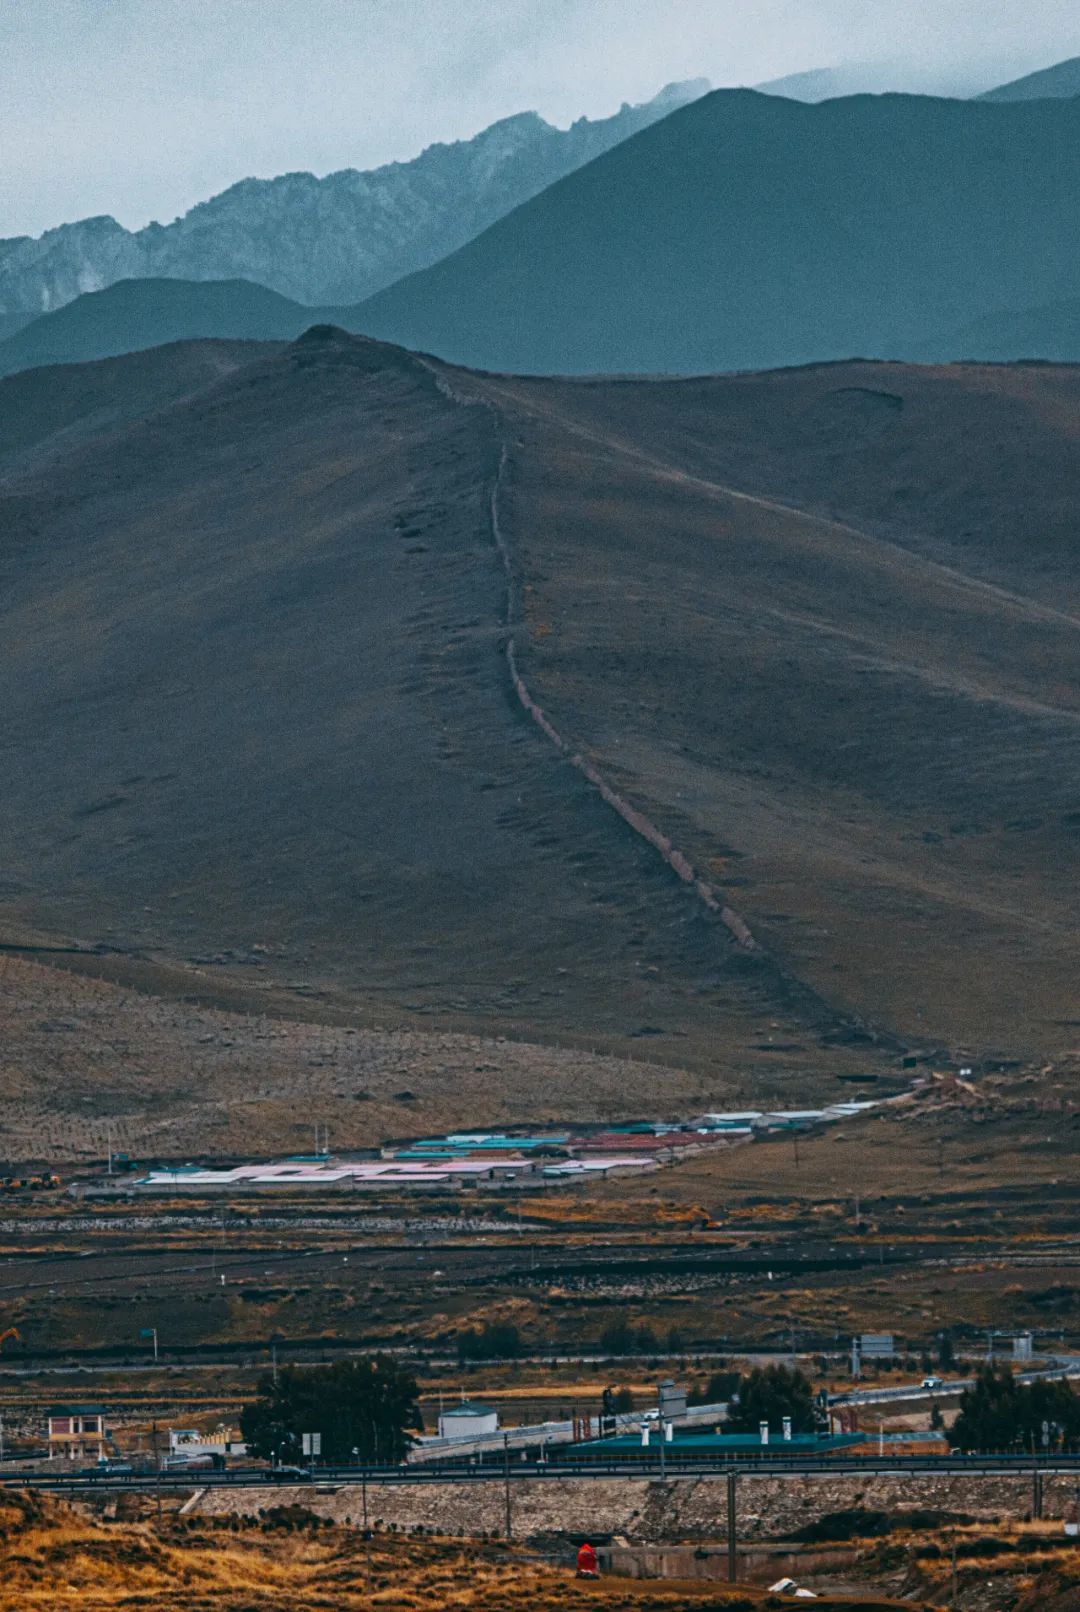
0,958,732,1161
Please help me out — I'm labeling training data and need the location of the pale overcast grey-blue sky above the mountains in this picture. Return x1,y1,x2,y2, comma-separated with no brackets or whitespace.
0,0,1080,235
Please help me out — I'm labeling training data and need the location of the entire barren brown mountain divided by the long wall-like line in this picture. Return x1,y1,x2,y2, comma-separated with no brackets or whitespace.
0,329,1080,1134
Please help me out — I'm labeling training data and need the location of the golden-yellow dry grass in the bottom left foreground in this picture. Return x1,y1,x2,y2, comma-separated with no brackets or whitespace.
0,1496,941,1612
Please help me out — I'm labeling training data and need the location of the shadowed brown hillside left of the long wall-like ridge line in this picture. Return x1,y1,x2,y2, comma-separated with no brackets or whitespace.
0,332,849,1072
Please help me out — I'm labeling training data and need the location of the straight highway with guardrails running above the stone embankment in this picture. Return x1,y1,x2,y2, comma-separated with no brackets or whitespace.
2,1454,1080,1494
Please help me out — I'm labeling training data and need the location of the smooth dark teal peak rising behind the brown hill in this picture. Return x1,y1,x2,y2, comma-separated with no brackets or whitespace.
359,90,1080,372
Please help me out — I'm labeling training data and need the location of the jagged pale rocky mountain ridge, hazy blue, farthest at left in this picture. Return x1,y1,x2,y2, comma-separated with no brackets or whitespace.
0,81,709,320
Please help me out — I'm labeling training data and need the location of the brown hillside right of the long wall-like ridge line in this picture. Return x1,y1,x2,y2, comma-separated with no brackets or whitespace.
464,364,1080,1053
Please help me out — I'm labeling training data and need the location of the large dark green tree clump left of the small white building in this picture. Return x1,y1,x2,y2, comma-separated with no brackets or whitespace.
240,1354,424,1465
